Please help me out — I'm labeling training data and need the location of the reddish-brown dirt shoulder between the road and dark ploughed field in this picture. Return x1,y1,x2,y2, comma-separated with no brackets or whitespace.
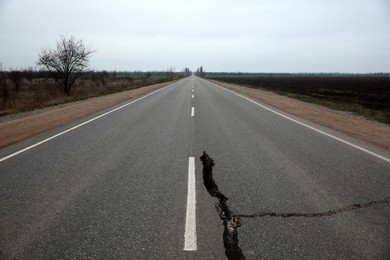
210,80,390,150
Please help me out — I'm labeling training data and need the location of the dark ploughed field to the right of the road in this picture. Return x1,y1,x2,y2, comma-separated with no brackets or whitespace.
206,72,390,125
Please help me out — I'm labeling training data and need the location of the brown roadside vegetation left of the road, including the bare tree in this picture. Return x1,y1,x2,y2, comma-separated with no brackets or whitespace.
0,35,190,116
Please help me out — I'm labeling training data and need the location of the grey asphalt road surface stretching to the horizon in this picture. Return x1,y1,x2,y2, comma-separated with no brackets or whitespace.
0,77,390,259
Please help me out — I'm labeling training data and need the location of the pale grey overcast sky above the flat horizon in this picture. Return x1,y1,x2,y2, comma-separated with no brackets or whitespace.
0,0,390,73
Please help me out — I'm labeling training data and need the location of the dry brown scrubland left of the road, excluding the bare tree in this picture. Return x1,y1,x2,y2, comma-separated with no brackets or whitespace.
0,68,185,116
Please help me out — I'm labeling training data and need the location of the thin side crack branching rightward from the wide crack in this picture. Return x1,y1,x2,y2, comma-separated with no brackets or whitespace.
236,197,390,218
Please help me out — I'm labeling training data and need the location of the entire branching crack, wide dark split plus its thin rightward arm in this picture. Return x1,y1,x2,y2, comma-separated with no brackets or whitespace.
200,152,390,260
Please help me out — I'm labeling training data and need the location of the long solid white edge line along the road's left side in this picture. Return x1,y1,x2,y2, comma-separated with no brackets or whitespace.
0,83,175,162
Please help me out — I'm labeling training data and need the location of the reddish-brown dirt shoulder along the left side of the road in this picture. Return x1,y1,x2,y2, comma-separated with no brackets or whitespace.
0,81,173,148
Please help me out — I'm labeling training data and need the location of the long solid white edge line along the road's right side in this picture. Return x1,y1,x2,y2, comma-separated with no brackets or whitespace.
210,82,390,163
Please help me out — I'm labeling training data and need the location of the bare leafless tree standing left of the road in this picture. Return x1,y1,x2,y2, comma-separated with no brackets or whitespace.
37,36,94,95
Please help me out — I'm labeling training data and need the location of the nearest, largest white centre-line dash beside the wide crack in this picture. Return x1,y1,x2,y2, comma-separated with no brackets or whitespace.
184,157,197,251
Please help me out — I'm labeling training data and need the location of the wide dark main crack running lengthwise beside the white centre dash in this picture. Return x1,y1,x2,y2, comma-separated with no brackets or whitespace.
200,152,246,260
